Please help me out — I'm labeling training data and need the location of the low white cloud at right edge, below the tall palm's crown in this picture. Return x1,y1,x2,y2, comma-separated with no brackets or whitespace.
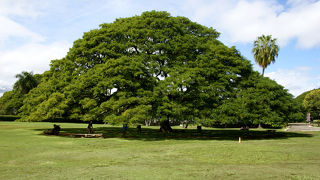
265,67,320,96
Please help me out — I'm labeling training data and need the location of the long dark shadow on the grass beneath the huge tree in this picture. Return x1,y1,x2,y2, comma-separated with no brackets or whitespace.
36,127,313,141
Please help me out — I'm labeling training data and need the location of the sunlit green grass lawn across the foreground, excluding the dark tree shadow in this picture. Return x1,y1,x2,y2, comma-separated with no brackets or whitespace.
0,122,320,179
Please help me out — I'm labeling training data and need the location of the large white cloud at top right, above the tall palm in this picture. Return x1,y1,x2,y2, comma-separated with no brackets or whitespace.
185,0,320,48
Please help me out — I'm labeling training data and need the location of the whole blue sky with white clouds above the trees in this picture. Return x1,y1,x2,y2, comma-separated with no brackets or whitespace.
0,0,320,96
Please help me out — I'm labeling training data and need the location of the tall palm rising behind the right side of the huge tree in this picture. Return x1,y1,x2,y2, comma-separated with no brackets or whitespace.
252,35,280,76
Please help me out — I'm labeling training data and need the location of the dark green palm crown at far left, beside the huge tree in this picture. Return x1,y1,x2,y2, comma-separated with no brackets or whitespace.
13,71,38,94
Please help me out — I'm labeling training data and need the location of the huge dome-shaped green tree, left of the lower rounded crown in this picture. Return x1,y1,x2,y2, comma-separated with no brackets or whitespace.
7,11,298,131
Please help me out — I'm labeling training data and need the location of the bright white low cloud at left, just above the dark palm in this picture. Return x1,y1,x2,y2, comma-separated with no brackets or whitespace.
0,42,71,89
